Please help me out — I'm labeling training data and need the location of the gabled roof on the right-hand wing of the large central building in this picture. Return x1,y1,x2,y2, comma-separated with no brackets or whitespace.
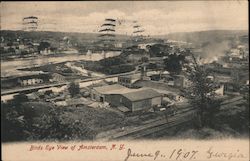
122,89,161,101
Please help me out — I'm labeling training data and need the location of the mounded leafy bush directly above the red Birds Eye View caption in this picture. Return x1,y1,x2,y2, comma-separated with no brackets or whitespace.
30,108,95,140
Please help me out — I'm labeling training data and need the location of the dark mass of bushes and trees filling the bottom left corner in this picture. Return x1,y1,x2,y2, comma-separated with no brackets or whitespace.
1,102,94,142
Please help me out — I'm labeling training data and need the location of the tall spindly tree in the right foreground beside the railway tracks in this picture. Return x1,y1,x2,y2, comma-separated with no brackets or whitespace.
186,50,220,128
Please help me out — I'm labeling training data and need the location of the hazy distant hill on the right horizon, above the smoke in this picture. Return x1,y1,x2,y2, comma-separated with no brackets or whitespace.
155,30,248,44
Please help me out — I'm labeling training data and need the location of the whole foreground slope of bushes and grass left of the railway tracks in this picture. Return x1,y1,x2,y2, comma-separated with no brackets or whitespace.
1,95,135,142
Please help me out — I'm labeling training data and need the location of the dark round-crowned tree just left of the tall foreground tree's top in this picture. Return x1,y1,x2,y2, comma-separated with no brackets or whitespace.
164,53,185,74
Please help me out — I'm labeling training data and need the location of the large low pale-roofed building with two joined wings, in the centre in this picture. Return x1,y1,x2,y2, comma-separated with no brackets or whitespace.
91,84,162,112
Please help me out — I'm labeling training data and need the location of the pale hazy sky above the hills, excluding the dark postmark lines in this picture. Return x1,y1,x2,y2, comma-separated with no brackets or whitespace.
1,0,248,35
